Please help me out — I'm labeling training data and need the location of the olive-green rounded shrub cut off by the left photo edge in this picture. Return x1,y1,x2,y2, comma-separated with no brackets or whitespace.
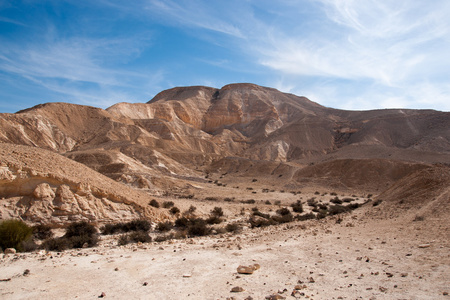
0,220,33,251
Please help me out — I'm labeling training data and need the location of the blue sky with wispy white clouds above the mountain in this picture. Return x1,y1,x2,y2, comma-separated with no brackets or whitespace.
0,0,450,112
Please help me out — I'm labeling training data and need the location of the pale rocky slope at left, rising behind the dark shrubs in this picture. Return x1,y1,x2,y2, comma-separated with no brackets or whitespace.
0,143,164,225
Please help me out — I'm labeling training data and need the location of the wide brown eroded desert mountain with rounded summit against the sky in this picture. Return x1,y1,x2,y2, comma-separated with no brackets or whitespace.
0,84,450,223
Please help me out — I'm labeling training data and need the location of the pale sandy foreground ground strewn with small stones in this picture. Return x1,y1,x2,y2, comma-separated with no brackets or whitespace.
0,204,450,299
